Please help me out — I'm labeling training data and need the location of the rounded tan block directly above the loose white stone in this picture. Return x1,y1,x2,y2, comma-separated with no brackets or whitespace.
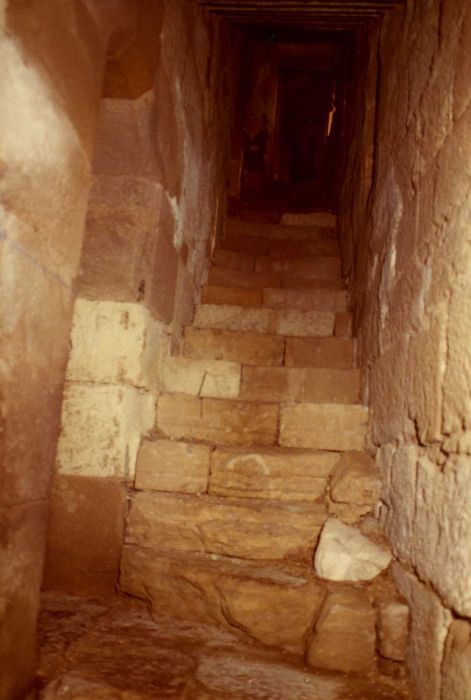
329,450,381,523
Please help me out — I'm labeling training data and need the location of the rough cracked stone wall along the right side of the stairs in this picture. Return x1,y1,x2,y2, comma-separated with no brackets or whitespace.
340,0,471,700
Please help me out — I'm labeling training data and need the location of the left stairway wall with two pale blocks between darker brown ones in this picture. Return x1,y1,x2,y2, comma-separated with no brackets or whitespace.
45,0,237,595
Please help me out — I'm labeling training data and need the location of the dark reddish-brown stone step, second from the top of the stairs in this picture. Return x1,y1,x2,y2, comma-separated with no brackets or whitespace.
221,233,340,258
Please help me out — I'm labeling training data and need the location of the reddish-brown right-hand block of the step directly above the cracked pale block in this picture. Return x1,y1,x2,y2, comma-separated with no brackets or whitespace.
285,338,353,369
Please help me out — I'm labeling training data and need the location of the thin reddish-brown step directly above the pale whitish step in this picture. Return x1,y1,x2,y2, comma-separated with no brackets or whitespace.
201,285,347,312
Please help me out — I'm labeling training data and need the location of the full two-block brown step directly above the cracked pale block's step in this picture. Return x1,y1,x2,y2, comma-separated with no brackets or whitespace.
184,326,354,369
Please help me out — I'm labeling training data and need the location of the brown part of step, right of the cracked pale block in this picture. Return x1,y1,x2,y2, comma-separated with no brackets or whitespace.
240,367,361,404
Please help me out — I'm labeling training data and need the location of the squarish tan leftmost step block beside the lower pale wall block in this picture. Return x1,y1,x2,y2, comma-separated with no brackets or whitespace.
134,440,211,493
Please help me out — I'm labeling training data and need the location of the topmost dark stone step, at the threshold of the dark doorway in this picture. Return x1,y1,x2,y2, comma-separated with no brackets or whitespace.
225,217,337,241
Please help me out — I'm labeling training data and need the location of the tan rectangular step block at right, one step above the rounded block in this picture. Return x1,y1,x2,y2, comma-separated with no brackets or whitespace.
280,403,368,451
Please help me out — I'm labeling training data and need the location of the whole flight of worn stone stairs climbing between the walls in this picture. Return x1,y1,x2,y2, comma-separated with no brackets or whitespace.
120,220,407,672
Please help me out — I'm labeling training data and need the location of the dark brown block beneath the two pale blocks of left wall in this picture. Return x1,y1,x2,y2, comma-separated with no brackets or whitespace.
43,474,127,596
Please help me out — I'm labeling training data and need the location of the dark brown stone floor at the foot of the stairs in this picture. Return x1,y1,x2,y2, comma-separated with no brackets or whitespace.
29,594,411,700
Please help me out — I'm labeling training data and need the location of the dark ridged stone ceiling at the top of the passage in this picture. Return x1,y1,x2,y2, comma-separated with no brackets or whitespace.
198,0,403,30
